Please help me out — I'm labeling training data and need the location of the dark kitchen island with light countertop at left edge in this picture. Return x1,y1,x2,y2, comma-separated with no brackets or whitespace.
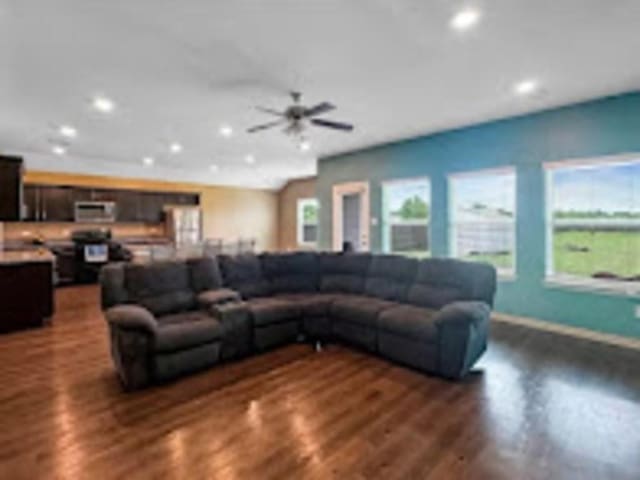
0,249,55,333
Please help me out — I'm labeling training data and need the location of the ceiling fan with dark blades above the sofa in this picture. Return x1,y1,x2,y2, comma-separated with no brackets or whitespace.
247,92,353,136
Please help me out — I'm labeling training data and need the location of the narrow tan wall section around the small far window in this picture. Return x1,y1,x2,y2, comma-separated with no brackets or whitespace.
278,177,316,250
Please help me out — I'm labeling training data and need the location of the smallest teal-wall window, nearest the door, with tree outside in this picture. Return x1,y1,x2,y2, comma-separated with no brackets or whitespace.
382,178,431,257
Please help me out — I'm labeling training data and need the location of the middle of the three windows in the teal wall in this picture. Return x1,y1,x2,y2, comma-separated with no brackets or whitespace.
449,168,516,275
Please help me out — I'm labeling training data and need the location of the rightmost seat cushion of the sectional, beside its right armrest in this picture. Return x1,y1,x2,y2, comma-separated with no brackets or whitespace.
378,305,437,343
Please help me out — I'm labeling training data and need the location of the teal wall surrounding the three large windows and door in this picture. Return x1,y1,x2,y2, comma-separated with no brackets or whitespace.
317,92,640,338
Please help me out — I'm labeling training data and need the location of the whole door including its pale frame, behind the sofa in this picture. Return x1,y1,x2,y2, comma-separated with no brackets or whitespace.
333,182,369,252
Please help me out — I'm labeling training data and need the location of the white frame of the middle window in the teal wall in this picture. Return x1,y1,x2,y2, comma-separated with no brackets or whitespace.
447,165,518,280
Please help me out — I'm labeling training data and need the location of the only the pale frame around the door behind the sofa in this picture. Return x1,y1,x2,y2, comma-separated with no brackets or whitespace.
331,182,371,252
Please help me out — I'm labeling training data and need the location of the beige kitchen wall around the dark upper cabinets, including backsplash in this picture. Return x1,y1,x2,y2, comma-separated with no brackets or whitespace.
4,171,278,250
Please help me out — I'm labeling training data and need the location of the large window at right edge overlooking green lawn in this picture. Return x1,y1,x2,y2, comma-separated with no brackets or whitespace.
546,158,640,291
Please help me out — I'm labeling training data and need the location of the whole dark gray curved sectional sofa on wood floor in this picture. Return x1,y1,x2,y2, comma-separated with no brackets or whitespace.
101,252,496,389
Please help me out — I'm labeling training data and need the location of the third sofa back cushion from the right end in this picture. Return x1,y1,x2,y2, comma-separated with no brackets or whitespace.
318,253,371,294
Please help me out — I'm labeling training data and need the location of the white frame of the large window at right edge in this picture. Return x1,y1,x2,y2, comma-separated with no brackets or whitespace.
542,153,640,297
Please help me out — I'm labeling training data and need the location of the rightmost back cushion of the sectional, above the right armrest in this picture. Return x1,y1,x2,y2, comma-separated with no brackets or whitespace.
407,258,496,308
